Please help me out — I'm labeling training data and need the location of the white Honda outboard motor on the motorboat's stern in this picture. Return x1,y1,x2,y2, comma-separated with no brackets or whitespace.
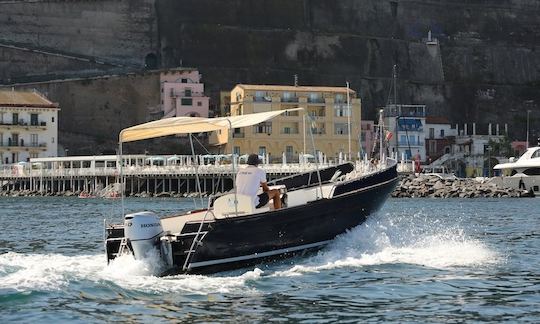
124,211,163,260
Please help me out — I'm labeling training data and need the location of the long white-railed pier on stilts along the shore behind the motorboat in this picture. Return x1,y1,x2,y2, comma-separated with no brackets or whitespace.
0,155,324,196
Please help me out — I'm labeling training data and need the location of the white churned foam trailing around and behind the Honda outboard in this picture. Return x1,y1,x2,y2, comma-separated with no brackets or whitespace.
0,252,263,295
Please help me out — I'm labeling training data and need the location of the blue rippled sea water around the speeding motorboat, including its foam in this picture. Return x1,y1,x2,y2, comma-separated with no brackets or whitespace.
0,198,540,323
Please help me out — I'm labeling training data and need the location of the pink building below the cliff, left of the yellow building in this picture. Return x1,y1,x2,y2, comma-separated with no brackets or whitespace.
160,68,209,118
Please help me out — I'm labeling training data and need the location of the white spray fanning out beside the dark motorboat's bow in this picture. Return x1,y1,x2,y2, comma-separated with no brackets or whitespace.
274,211,501,276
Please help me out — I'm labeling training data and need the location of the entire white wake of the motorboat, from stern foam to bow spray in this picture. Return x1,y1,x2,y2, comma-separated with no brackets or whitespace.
0,211,501,295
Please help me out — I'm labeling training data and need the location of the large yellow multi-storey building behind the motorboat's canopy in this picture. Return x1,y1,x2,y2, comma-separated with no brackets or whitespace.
210,84,361,162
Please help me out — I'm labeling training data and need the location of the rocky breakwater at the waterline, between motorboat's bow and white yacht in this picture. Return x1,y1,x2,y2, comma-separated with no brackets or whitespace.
392,175,531,198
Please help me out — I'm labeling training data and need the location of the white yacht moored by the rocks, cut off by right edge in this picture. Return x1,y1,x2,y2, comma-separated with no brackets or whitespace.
493,146,540,196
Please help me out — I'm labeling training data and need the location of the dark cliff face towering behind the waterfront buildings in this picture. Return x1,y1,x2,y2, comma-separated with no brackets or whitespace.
0,0,540,151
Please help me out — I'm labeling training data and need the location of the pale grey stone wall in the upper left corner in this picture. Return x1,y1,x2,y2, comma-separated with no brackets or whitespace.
0,0,159,67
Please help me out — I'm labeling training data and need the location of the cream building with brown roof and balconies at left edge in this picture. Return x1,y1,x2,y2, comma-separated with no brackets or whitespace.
0,90,60,164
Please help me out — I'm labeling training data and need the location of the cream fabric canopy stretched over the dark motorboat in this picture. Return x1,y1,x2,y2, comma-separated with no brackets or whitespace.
119,108,303,143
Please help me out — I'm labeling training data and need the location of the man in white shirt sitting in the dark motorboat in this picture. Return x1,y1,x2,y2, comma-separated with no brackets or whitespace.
236,154,281,209
